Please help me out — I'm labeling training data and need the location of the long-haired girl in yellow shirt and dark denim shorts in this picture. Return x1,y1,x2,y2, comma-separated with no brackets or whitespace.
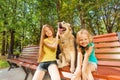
32,24,61,80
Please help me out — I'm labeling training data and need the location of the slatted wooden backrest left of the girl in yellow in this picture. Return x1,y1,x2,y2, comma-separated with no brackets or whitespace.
18,46,39,65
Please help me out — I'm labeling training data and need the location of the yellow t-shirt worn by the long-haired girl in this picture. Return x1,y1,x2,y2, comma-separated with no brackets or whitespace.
41,39,57,62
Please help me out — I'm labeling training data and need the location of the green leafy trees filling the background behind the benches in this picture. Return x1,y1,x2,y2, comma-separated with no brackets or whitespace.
0,0,120,55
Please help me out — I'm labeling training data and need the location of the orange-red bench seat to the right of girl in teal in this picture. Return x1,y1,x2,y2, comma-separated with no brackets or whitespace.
93,66,120,80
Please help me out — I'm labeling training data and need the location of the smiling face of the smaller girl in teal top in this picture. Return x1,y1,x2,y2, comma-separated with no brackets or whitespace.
78,34,89,47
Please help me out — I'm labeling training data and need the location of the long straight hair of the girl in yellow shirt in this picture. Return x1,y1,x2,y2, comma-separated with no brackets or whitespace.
38,24,54,62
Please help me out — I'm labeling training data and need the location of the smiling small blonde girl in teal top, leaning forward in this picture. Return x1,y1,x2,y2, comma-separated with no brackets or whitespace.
71,29,98,80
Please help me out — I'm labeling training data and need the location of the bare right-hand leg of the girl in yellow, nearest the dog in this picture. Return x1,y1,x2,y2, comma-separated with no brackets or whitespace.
48,64,61,80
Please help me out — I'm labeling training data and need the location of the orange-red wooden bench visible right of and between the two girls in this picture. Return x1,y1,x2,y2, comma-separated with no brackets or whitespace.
60,32,120,80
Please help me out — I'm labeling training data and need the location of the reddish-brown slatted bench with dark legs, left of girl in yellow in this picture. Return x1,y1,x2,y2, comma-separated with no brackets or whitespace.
7,46,39,80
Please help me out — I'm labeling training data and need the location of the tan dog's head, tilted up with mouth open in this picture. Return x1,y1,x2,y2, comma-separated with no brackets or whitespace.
58,21,72,36
